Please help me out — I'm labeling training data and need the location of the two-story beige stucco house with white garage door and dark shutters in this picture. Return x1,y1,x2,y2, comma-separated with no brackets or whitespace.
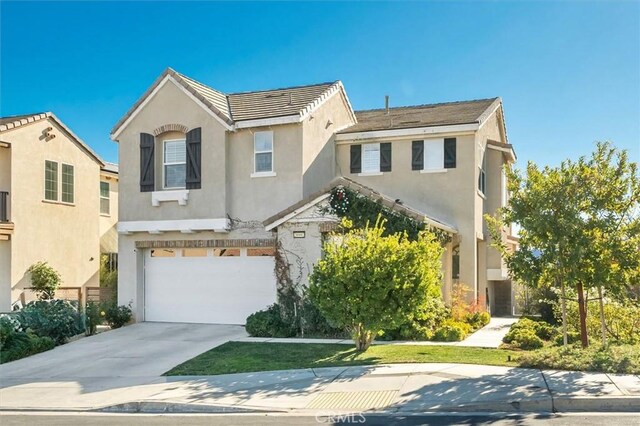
111,69,515,324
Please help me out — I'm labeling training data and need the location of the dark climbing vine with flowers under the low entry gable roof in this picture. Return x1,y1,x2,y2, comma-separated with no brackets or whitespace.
325,186,451,244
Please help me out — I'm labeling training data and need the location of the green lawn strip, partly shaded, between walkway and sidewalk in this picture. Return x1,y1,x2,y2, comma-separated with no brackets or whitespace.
165,342,517,376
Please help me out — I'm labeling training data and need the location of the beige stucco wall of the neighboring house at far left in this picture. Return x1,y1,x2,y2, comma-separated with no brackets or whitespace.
2,119,100,305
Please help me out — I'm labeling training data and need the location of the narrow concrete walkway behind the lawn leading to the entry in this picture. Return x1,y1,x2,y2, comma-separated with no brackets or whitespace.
234,317,519,348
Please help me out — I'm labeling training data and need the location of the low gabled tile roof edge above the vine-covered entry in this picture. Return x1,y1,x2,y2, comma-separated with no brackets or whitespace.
262,176,458,234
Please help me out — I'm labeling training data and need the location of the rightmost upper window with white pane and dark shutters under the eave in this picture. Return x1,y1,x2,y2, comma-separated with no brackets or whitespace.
411,138,456,171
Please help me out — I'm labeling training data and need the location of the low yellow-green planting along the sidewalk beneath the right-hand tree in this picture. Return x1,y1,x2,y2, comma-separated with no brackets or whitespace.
519,345,640,374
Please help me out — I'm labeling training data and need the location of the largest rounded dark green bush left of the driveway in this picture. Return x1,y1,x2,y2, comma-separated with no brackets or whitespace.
17,299,84,345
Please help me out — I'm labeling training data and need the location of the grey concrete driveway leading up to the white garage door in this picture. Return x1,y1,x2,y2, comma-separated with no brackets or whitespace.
0,322,247,380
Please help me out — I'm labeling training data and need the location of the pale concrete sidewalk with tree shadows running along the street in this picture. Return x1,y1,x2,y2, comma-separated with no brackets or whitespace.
0,364,640,413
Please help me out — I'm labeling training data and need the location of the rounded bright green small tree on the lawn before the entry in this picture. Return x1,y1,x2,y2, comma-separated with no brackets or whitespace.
309,217,443,350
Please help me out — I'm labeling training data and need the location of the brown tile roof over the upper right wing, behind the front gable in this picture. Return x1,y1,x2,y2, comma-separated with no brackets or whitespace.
338,98,500,133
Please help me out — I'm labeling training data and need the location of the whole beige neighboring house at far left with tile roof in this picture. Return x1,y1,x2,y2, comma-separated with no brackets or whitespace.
0,112,117,312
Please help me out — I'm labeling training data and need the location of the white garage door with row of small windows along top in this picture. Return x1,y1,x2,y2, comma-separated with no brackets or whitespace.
144,248,276,324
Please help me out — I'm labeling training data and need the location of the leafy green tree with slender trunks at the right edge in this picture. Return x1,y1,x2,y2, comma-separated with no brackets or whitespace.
486,143,640,347
